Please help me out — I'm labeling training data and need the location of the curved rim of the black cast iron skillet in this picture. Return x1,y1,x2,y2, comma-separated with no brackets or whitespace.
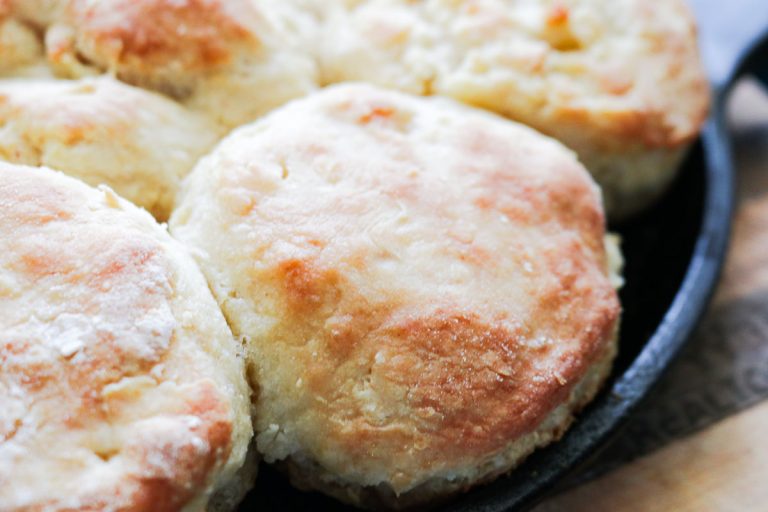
448,102,734,512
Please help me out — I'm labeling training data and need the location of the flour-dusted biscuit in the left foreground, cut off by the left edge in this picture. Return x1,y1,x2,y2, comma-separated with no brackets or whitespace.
0,163,255,512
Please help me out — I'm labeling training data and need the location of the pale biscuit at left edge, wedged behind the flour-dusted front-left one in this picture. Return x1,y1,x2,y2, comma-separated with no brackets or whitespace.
0,77,222,220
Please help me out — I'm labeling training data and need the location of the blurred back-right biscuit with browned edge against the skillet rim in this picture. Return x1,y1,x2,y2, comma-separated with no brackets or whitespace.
317,0,709,219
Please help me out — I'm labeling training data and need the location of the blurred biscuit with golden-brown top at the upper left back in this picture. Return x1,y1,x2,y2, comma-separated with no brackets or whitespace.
45,0,317,127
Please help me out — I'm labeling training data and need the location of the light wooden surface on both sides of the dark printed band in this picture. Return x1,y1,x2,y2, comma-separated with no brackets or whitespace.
535,80,768,512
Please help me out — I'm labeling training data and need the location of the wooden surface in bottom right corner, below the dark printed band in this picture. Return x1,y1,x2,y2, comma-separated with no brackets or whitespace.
535,402,768,512
